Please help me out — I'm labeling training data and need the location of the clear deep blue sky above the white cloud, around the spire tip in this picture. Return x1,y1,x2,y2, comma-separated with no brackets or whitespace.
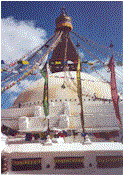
1,1,123,54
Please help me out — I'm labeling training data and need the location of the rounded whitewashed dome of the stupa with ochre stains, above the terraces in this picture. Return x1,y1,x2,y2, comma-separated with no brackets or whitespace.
13,71,111,107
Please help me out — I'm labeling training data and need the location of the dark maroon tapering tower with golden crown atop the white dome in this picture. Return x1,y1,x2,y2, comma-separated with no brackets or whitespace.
49,8,78,73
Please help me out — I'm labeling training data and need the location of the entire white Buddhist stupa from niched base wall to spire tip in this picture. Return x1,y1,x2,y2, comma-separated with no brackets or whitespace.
1,8,123,175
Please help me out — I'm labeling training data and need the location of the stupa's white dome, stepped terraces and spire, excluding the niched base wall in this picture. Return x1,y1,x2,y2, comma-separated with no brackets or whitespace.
1,8,123,134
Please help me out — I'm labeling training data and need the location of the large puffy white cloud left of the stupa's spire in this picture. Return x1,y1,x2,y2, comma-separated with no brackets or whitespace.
1,17,46,63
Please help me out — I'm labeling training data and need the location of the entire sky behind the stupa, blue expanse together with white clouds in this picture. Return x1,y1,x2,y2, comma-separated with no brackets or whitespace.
1,1,123,108
